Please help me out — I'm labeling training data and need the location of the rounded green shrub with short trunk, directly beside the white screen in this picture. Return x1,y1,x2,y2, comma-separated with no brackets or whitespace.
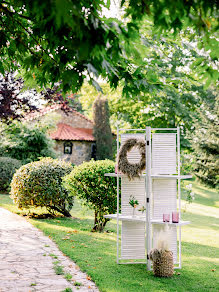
64,160,117,231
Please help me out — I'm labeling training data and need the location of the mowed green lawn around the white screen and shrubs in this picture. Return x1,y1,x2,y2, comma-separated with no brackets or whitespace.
0,182,219,292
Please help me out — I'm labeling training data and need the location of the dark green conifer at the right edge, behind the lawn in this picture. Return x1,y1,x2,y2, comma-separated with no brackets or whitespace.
192,96,219,187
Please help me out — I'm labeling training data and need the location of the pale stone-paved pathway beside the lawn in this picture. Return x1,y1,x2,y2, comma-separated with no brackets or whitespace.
0,208,99,292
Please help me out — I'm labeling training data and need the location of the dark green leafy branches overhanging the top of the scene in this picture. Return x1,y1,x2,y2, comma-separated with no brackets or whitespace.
0,0,218,93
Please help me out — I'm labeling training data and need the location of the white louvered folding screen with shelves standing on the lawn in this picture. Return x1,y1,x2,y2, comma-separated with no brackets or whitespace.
105,127,192,270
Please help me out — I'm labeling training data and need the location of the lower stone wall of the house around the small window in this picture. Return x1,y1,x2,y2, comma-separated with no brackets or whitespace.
55,140,93,165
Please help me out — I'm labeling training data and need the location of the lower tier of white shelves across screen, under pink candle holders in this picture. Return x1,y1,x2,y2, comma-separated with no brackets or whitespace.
104,214,190,226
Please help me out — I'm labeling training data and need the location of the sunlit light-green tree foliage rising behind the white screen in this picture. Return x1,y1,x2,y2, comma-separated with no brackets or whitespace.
80,21,218,148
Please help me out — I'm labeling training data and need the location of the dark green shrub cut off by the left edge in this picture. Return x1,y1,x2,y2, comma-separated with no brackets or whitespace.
0,157,21,192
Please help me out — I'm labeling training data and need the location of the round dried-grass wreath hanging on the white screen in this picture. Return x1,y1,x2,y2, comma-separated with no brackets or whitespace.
118,138,146,180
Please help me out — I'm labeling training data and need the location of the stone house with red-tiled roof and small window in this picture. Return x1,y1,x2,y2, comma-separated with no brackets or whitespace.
26,104,96,165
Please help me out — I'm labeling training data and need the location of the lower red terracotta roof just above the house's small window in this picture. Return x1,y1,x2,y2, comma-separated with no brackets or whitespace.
50,123,95,141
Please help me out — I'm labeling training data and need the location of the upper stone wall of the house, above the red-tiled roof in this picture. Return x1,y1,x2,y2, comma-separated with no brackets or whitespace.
56,109,93,129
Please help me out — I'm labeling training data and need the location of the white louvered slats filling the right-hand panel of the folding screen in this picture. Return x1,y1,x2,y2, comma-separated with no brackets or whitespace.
150,133,178,263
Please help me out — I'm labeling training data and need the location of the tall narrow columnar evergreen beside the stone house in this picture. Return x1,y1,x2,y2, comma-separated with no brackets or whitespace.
93,98,112,160
